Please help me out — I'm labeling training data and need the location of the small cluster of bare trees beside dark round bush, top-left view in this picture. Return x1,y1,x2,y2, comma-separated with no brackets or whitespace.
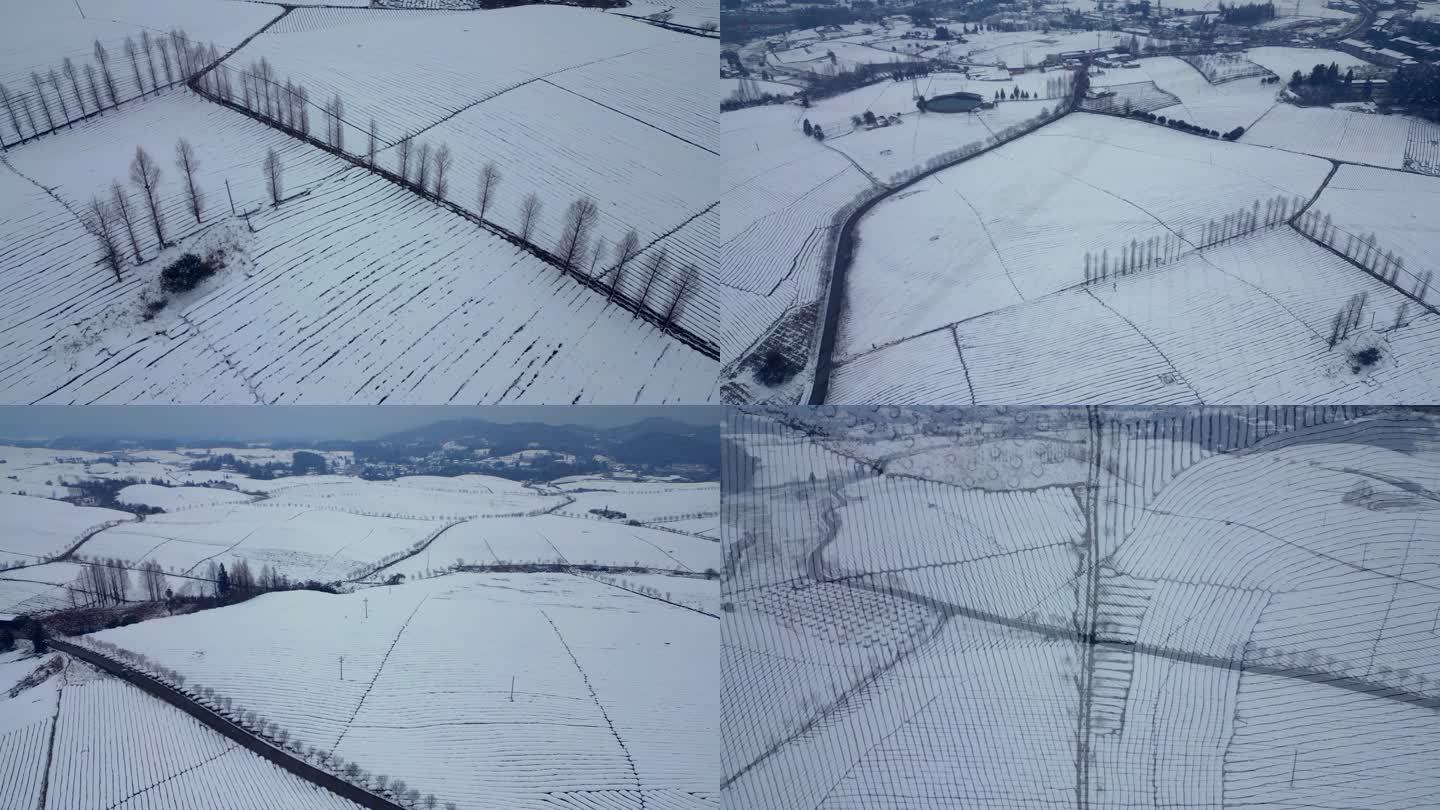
81,138,204,281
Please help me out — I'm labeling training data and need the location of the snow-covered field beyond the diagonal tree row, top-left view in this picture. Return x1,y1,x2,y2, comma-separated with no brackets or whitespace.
228,4,719,343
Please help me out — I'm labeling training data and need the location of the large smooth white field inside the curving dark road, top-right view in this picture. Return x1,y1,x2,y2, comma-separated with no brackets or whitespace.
837,114,1329,357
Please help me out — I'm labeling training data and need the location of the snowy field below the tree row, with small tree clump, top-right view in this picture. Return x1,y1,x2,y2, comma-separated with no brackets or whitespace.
831,228,1440,404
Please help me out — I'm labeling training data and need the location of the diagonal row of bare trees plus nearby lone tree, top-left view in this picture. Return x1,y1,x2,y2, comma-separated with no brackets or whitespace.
211,59,700,334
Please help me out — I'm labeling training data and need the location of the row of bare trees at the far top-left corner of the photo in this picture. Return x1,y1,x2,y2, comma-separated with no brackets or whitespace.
0,29,217,147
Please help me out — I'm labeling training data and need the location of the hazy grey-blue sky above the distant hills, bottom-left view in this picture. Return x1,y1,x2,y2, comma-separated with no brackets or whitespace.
0,405,721,441
